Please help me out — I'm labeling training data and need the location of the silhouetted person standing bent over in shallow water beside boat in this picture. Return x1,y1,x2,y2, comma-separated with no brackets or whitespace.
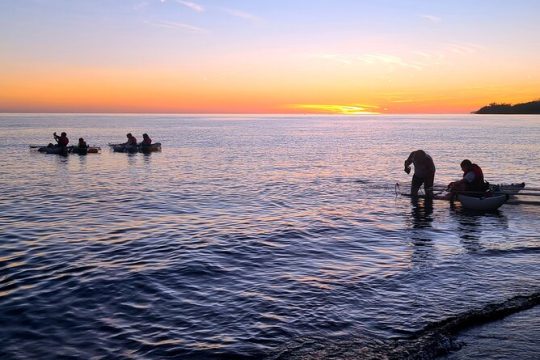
404,150,435,197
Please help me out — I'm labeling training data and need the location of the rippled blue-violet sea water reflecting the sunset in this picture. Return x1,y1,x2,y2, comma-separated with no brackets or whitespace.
0,114,540,359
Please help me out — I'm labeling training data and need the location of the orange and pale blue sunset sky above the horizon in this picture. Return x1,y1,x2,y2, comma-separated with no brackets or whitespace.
0,0,540,114
